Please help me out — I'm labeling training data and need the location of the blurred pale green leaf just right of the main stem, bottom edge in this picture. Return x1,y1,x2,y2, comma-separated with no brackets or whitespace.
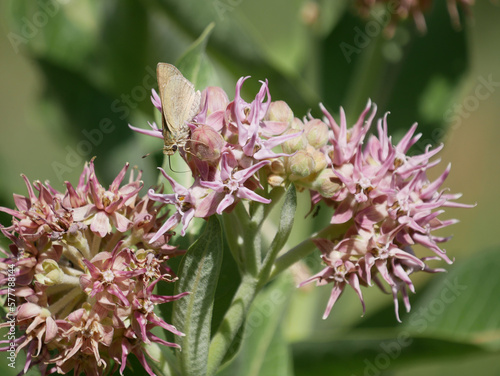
218,276,293,376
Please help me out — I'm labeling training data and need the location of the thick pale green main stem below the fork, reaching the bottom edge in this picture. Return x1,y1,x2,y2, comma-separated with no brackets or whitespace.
207,275,257,376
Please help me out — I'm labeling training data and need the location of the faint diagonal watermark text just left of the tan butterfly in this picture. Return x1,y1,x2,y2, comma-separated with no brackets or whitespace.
52,66,156,182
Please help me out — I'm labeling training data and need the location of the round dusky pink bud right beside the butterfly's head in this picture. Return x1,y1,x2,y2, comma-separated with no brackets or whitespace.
191,125,224,162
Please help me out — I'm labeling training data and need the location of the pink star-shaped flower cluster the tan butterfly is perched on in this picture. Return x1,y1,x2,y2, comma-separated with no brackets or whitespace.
130,77,297,241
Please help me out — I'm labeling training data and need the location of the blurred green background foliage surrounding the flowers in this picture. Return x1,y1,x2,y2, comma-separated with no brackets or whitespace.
0,0,500,376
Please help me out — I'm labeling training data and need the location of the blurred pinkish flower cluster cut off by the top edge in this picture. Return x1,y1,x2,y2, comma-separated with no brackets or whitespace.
356,0,475,33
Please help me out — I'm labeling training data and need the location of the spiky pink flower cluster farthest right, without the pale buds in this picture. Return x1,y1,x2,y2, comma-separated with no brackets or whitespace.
300,102,471,321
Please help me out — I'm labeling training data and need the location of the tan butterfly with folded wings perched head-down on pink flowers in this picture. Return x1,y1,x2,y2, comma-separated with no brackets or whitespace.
156,63,201,155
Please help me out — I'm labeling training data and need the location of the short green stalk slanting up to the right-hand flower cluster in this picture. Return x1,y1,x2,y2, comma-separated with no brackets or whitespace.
268,221,352,281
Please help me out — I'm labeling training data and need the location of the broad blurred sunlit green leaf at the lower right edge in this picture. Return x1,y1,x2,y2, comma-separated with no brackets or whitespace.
403,249,500,350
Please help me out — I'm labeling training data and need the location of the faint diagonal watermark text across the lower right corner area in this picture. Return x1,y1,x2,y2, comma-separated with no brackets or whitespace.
352,278,467,376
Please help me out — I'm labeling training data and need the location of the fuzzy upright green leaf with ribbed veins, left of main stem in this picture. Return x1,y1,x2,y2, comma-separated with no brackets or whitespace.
172,216,223,376
